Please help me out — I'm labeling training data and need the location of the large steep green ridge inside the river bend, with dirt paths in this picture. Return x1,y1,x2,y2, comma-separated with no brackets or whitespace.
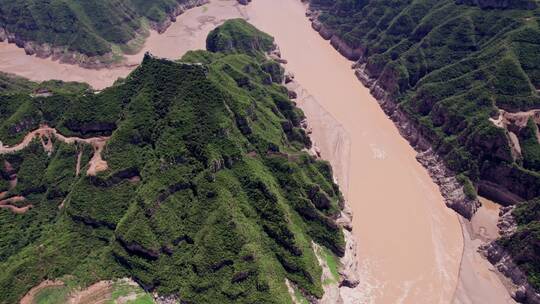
0,21,345,303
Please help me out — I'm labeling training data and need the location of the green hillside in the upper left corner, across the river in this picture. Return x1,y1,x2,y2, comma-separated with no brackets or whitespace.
0,0,200,56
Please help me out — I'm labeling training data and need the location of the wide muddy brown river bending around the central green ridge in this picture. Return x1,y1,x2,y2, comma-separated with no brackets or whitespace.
0,0,516,304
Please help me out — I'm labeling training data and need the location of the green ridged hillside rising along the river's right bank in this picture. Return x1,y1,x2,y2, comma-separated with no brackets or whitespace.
310,0,540,287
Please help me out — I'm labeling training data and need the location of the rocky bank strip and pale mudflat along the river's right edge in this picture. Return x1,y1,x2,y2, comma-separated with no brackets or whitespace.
306,1,515,303
